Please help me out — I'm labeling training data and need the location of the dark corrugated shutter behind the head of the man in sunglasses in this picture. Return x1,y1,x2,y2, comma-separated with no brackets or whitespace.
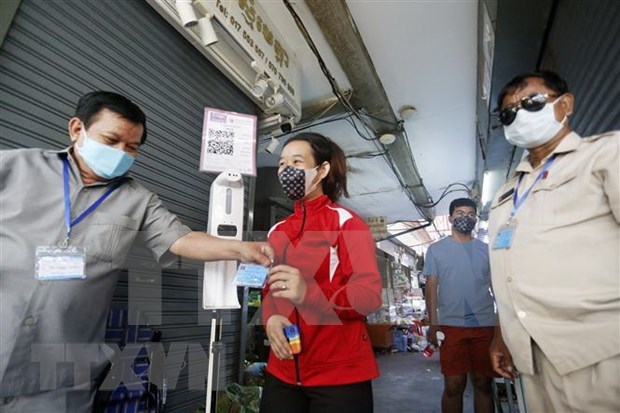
541,0,620,136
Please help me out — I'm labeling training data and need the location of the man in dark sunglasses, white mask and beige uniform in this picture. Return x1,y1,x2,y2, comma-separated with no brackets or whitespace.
489,72,620,413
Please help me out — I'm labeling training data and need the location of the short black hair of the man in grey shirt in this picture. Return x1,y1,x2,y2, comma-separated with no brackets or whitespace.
74,90,146,144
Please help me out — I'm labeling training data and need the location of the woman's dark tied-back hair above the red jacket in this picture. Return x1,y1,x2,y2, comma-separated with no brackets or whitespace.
284,132,349,202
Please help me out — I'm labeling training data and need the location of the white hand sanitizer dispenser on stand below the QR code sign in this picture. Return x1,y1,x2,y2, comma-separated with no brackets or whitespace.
202,171,244,310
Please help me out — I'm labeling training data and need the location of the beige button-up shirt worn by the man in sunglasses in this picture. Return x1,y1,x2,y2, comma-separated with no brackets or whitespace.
489,131,620,375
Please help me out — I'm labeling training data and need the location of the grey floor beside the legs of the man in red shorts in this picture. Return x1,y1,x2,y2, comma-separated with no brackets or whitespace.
372,353,474,413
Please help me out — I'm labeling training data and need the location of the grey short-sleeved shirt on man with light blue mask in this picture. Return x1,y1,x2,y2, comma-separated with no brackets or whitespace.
0,149,191,397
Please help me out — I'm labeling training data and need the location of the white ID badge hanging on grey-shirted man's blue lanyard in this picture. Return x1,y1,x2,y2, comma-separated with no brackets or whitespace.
34,246,86,281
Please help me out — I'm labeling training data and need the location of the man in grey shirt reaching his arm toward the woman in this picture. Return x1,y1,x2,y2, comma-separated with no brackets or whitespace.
0,92,273,412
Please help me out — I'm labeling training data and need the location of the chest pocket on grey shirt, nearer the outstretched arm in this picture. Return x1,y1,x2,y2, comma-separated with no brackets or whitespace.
86,212,140,266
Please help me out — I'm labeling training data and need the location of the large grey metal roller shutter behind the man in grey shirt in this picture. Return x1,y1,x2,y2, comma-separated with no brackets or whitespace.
0,0,258,412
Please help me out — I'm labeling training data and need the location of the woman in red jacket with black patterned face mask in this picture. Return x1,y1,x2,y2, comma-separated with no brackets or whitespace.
260,133,381,413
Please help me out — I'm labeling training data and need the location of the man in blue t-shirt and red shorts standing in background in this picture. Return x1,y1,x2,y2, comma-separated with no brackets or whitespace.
423,198,496,413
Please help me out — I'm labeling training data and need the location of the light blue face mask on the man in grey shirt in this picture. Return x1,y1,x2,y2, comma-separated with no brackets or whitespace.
75,127,135,179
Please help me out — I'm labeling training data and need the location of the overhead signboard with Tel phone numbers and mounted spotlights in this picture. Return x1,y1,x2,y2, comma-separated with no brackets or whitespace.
145,0,301,120
